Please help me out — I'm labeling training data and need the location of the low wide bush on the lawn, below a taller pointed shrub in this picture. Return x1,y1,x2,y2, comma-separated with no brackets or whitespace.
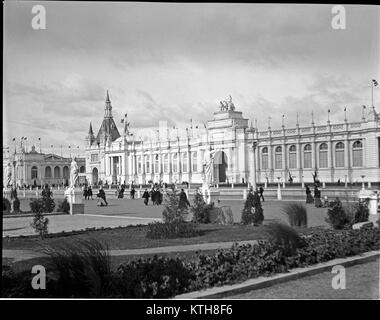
146,220,201,239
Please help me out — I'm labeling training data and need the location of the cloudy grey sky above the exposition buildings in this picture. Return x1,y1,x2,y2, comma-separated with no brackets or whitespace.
3,1,380,153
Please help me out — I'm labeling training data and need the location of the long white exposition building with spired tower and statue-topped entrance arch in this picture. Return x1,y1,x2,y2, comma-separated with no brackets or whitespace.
85,92,380,184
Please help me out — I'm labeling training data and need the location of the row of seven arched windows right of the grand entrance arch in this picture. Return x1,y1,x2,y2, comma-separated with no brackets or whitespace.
261,141,363,170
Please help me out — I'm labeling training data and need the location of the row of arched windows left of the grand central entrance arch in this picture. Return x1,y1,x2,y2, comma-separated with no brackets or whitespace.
137,152,198,174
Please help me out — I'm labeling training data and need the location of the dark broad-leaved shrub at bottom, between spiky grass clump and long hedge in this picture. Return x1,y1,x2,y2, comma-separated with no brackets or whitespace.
115,256,195,298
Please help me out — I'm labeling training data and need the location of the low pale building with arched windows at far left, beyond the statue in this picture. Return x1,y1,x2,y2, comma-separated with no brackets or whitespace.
3,145,86,187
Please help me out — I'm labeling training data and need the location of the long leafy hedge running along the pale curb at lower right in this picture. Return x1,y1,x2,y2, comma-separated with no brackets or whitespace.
190,228,380,290
